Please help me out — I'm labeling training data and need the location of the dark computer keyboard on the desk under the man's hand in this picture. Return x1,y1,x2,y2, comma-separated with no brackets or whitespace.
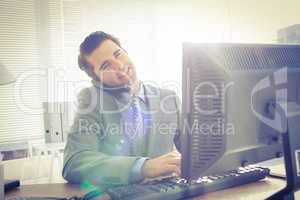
107,166,270,200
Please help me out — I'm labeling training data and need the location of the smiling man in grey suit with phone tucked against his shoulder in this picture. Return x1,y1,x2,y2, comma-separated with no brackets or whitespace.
63,31,181,187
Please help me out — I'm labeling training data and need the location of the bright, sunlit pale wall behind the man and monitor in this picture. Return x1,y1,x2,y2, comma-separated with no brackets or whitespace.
65,0,300,94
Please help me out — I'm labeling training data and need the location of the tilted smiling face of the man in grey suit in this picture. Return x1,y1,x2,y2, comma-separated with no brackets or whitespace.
86,40,136,87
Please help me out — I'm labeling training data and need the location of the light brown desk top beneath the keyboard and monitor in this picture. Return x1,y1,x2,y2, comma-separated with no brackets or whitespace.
5,178,300,200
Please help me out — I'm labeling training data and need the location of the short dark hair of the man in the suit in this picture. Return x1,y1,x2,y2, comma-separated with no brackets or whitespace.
78,31,121,81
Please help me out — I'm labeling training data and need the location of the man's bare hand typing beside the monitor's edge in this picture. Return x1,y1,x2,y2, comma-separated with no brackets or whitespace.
142,151,181,178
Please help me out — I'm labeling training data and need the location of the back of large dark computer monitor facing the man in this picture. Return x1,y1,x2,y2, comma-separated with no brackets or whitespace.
180,43,300,180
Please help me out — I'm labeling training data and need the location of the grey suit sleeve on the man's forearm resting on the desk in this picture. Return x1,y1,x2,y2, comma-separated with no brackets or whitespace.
63,151,140,186
